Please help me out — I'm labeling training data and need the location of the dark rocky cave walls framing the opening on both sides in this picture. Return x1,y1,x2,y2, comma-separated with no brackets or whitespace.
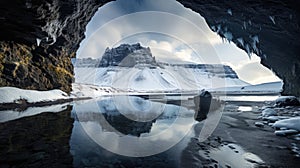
0,0,300,95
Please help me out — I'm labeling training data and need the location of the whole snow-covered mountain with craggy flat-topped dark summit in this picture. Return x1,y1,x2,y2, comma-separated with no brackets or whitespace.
74,44,249,91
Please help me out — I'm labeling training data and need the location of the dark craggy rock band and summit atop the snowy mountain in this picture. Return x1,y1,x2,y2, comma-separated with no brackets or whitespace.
74,43,238,79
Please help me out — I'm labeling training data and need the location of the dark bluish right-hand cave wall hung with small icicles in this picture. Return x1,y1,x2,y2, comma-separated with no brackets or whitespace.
177,0,300,95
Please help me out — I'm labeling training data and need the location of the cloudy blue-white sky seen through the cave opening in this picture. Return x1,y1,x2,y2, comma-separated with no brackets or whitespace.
77,0,280,84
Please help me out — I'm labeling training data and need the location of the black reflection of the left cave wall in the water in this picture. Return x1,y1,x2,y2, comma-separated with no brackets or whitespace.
0,107,73,167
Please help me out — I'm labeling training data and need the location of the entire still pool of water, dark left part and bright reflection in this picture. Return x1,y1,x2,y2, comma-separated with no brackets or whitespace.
0,96,263,167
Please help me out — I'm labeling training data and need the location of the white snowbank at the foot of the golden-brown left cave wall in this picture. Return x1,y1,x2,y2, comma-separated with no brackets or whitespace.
0,87,69,103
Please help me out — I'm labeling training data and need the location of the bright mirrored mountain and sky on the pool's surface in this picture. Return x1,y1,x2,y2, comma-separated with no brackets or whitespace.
70,96,262,167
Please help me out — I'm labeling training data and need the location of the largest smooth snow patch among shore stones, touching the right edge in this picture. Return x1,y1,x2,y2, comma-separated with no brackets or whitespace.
273,117,300,131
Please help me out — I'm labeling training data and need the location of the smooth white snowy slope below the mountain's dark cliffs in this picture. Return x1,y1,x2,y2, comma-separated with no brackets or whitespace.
75,66,249,91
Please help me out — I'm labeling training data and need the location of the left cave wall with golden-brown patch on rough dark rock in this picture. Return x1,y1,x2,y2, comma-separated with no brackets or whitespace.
0,0,111,92
